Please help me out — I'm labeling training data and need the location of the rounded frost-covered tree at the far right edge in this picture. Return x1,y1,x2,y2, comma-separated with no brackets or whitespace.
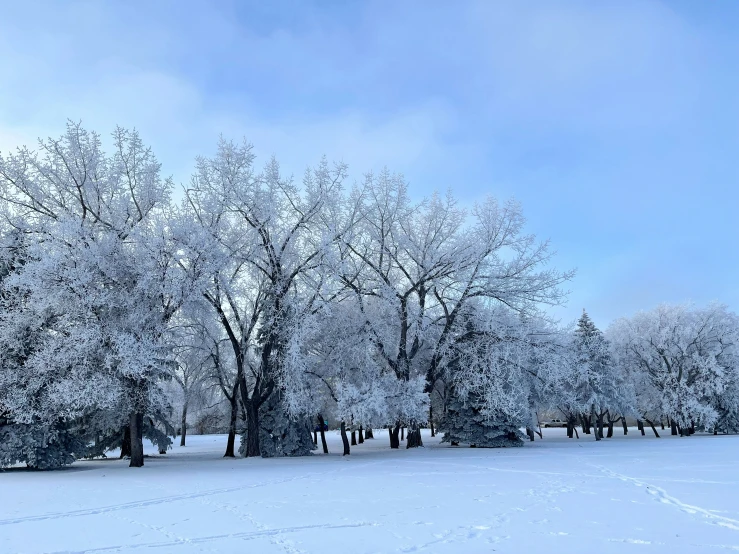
609,304,739,435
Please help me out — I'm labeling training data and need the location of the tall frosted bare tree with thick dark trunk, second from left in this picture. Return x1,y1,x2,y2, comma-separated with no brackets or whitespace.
187,141,345,456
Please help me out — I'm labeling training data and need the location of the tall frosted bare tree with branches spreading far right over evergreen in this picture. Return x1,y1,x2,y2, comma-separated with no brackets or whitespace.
343,175,570,447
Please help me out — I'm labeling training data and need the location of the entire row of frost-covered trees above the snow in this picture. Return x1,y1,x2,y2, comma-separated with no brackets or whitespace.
0,123,739,467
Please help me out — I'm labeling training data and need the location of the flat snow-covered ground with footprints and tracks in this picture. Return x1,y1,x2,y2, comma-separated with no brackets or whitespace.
0,429,739,554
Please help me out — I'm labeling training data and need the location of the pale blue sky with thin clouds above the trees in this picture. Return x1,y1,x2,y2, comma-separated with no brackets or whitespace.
0,0,739,327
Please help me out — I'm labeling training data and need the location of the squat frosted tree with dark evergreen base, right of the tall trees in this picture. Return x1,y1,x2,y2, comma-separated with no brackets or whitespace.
440,301,567,447
